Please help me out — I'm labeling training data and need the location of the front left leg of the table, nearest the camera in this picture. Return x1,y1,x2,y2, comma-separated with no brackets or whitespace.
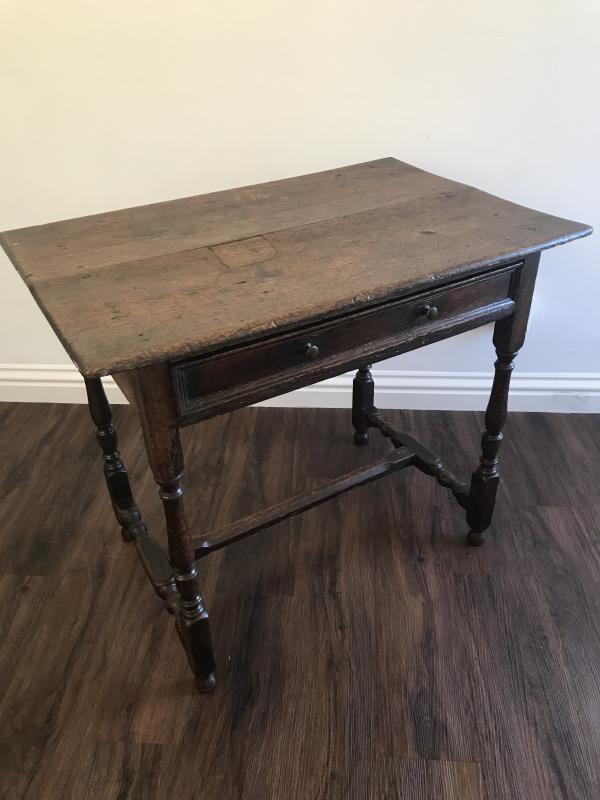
135,366,216,692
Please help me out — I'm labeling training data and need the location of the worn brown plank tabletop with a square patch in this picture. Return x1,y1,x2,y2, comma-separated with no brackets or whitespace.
0,158,591,376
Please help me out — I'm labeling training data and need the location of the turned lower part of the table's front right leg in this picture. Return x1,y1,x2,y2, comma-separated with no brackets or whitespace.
467,349,516,547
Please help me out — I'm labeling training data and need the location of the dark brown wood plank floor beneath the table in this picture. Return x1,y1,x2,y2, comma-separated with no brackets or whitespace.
0,404,600,800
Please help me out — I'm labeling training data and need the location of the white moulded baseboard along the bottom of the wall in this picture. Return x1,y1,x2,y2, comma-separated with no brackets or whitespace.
0,364,600,413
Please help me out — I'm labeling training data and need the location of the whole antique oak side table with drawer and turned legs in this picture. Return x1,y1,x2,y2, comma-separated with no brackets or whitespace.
1,158,591,691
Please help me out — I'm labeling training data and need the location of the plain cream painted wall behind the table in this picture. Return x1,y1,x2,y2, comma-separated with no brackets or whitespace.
0,0,600,409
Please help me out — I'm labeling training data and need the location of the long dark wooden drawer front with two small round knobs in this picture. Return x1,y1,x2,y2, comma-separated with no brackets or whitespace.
173,264,520,420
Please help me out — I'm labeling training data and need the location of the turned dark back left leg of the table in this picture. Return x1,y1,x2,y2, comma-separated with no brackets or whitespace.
84,378,146,542
